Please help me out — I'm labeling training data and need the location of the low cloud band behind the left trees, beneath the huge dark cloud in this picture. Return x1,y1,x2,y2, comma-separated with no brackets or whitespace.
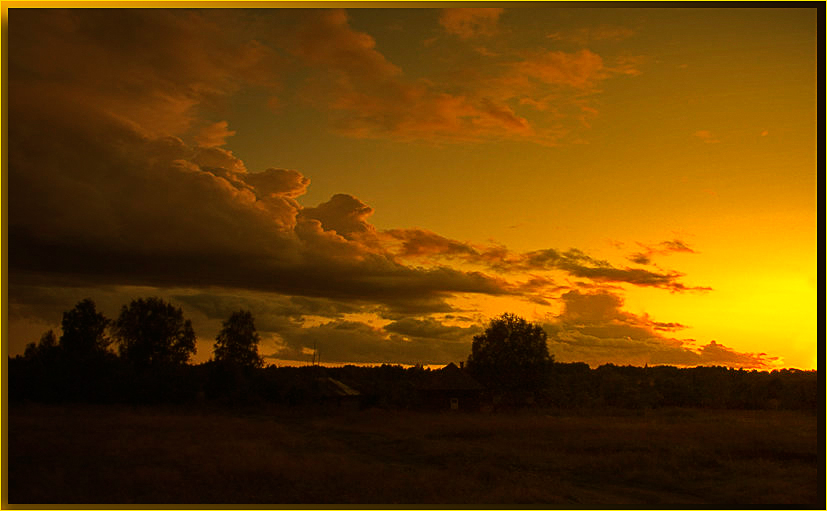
4,284,466,364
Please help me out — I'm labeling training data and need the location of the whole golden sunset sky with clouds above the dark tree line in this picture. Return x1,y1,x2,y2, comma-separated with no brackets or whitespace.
3,3,823,369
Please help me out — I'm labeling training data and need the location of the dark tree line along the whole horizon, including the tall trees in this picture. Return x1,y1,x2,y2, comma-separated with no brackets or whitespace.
6,298,821,411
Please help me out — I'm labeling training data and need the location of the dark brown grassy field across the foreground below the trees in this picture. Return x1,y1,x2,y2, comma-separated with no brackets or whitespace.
4,405,825,509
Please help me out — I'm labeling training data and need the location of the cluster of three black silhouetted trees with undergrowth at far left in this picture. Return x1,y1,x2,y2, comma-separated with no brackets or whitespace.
8,297,263,402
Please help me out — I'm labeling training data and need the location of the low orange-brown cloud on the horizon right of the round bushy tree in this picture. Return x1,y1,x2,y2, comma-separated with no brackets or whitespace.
544,291,772,369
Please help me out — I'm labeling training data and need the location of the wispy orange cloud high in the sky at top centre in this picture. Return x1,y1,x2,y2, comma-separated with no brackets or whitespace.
288,9,637,145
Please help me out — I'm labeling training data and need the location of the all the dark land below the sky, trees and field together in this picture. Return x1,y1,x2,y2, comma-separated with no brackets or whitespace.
4,299,825,508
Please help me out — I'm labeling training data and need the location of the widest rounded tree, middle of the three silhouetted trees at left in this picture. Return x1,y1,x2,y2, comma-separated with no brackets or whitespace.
113,297,195,367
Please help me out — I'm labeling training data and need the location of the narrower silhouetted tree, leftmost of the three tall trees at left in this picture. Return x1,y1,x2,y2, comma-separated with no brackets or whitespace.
60,298,111,361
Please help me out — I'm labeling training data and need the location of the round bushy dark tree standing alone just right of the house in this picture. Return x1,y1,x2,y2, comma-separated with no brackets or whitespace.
468,313,553,392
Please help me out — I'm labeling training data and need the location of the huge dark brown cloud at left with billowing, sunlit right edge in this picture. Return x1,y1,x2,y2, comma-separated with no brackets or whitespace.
8,11,507,310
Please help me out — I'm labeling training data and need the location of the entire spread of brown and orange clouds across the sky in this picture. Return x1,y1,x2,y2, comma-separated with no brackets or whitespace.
7,9,764,366
